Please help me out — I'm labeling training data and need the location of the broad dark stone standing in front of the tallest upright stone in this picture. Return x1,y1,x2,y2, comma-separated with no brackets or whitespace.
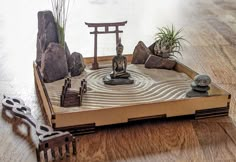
41,43,68,82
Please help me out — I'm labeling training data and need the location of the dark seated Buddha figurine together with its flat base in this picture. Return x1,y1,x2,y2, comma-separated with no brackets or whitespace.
103,41,134,85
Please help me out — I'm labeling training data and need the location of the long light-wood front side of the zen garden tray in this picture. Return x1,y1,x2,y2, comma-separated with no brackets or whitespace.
52,95,229,128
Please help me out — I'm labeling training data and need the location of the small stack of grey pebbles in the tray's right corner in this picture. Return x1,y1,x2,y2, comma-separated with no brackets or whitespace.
186,75,211,97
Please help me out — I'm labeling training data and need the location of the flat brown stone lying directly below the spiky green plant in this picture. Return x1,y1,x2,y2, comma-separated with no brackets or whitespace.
145,55,176,70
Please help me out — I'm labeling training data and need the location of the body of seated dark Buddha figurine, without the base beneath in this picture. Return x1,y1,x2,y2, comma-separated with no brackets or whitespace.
110,42,130,79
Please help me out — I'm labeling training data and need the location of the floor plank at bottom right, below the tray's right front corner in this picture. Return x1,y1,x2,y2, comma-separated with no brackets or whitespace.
193,121,236,161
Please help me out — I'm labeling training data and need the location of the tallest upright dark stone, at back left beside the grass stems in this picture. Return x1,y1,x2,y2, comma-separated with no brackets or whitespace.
36,11,58,66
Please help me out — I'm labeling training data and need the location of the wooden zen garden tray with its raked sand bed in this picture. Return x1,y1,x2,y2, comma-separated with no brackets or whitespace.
34,55,230,134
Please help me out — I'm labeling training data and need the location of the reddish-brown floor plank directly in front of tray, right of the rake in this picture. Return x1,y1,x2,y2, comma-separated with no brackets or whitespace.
78,121,205,161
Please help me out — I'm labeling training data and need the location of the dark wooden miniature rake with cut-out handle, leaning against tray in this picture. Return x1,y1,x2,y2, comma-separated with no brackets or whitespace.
2,96,76,161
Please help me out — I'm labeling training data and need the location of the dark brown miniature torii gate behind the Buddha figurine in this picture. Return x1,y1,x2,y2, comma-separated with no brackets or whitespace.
85,21,127,69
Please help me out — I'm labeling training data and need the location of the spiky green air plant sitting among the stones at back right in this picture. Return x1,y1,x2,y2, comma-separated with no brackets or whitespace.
154,25,185,58
